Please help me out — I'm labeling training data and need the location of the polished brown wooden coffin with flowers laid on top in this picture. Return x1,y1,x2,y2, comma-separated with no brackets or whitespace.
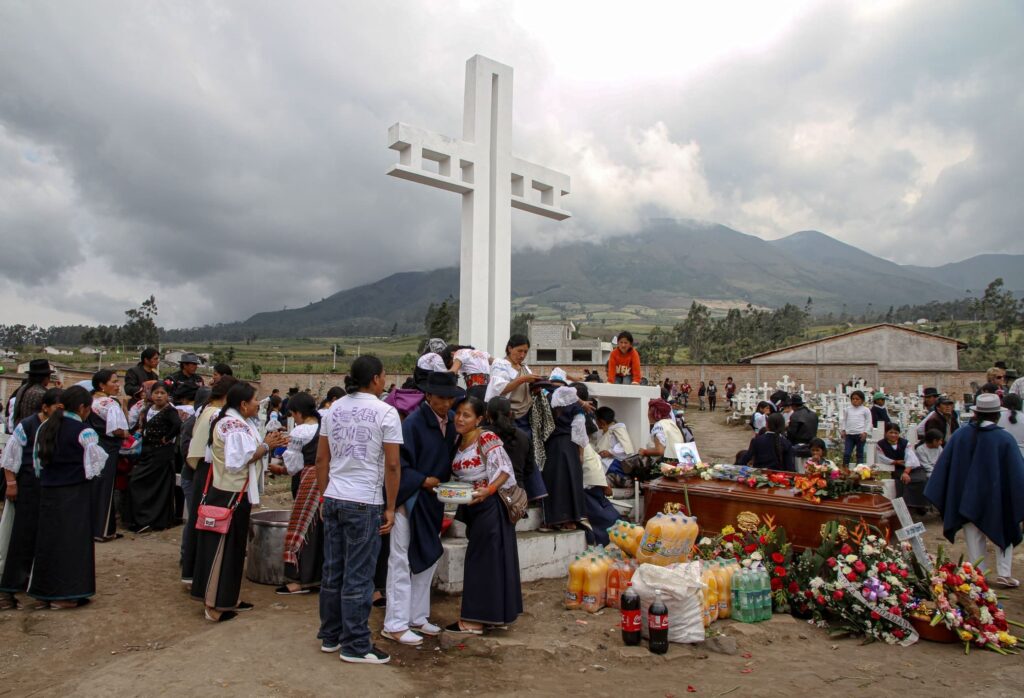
643,478,899,549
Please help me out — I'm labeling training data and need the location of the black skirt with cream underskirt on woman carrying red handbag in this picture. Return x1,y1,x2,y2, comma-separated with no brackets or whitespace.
188,476,252,611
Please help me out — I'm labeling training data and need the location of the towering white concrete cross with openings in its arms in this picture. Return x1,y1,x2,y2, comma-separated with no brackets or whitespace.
388,55,570,356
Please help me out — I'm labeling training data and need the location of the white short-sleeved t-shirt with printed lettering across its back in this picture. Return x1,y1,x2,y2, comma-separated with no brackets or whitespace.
321,393,401,505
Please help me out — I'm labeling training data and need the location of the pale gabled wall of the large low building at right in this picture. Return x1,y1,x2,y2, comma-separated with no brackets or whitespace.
751,326,959,370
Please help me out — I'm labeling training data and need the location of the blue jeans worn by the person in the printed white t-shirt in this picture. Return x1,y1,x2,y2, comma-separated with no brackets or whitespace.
316,498,384,656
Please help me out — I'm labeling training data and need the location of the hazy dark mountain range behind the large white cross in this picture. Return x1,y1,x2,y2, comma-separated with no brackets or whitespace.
234,220,1024,337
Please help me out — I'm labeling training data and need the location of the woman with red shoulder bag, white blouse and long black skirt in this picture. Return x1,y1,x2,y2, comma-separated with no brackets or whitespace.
191,383,288,621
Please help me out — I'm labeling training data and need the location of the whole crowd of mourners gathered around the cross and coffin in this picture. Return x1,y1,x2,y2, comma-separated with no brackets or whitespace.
0,341,1024,663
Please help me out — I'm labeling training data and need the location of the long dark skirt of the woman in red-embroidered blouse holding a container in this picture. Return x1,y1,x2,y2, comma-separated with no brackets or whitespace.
459,496,522,625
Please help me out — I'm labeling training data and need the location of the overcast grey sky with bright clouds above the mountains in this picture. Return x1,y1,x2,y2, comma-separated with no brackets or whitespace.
0,0,1024,326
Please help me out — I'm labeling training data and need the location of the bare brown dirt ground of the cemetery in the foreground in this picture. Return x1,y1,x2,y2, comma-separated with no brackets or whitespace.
0,410,1024,698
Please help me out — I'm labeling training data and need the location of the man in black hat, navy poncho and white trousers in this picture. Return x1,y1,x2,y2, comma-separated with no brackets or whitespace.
381,372,465,645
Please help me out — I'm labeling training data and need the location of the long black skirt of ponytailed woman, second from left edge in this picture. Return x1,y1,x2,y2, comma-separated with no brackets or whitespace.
28,482,96,601
